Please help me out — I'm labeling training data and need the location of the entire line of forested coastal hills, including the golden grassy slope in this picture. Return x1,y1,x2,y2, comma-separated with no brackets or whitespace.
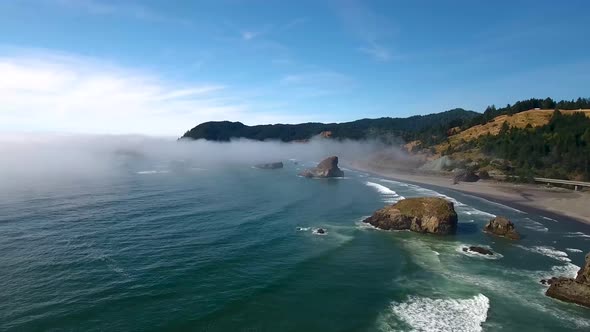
182,98,590,181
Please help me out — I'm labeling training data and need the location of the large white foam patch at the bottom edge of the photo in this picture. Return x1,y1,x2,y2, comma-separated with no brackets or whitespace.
391,294,490,332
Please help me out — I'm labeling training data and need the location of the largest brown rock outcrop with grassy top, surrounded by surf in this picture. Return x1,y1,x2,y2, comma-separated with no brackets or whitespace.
363,197,457,234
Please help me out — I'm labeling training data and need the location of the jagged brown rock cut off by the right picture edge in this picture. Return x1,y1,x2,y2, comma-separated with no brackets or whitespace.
545,253,590,308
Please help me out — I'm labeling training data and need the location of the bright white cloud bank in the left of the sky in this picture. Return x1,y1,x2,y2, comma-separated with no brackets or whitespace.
0,47,300,135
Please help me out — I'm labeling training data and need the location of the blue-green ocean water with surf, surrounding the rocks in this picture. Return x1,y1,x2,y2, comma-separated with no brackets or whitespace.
0,162,590,331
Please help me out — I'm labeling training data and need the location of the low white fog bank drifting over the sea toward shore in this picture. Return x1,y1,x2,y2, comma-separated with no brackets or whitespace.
0,135,416,192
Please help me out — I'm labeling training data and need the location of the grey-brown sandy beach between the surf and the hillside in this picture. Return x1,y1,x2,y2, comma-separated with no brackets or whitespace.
351,162,590,225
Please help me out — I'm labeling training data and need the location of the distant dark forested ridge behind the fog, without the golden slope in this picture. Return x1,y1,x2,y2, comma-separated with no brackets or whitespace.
181,108,481,142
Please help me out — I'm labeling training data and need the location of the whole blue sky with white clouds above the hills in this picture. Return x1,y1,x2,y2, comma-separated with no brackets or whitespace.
0,0,590,137
